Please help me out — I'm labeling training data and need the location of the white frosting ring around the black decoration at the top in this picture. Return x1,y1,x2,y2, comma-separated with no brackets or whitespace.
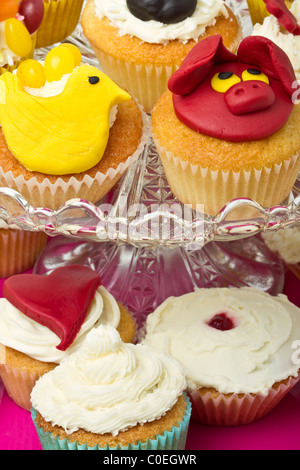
95,0,228,44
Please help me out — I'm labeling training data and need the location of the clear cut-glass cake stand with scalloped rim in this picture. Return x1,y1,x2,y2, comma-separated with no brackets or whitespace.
0,0,300,322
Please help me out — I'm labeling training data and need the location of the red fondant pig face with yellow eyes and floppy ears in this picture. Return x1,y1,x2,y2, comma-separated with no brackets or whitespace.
169,35,296,142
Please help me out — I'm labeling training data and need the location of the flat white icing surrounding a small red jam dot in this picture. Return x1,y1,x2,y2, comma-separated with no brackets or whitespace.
143,288,300,394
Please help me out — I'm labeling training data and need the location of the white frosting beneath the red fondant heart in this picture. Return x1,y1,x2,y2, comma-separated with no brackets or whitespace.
0,286,120,363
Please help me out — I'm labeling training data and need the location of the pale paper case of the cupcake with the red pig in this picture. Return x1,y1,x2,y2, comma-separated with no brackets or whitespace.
152,133,300,218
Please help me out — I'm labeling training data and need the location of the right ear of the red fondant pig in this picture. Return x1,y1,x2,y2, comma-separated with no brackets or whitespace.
237,36,296,96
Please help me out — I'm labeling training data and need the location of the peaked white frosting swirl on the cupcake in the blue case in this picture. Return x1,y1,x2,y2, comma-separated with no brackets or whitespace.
31,325,186,435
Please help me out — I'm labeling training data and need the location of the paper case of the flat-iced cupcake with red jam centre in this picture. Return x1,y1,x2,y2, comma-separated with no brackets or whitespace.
189,375,300,426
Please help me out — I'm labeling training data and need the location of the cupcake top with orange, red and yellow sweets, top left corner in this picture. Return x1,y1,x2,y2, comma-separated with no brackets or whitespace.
0,0,44,74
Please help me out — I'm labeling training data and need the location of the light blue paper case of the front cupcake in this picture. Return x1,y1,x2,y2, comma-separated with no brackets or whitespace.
31,394,192,451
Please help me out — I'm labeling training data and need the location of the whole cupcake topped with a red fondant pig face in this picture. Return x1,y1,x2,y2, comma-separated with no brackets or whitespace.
152,35,300,216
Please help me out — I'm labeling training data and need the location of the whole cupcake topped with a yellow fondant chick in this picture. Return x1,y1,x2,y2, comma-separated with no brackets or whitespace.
0,45,147,209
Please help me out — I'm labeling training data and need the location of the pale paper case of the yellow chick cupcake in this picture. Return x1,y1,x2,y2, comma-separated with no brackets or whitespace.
0,110,148,209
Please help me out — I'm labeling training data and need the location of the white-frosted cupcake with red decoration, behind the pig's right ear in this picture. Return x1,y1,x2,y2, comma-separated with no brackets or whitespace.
251,0,300,81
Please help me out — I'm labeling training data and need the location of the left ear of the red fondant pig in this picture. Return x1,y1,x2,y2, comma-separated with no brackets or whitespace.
168,34,237,96
